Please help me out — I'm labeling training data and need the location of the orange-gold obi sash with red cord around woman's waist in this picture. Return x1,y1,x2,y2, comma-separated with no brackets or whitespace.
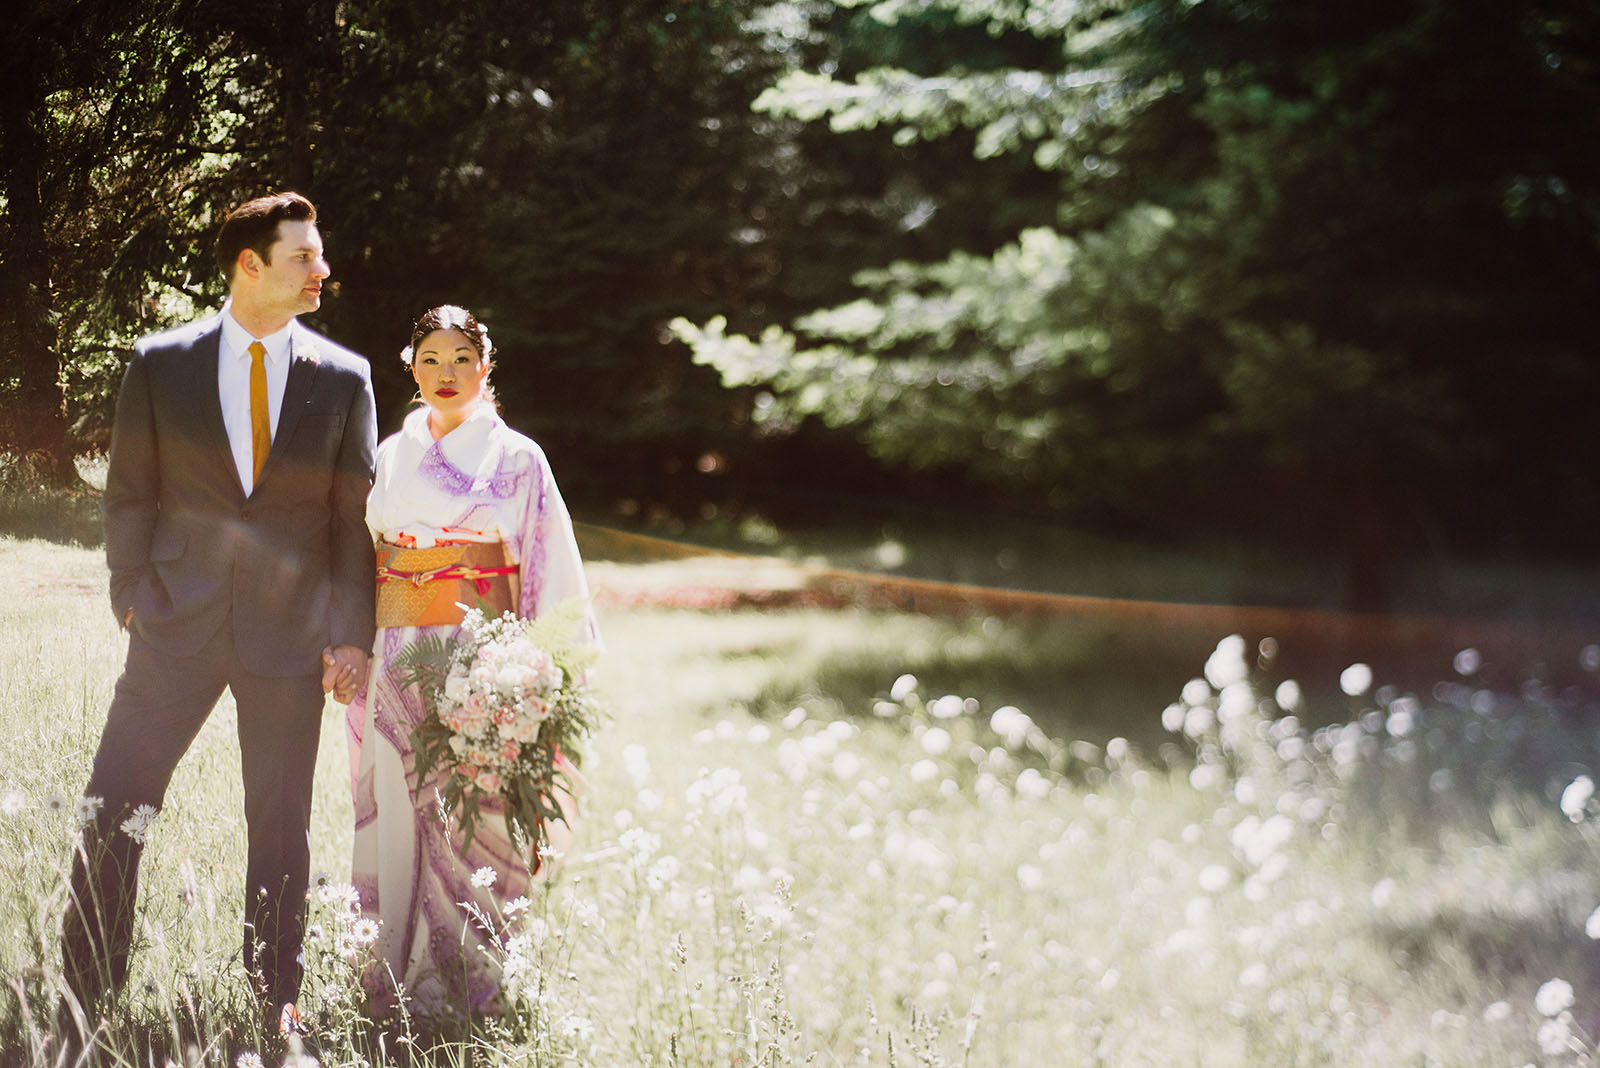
378,542,517,627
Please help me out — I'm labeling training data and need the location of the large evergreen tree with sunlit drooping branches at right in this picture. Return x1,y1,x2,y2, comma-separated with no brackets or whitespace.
675,0,1600,603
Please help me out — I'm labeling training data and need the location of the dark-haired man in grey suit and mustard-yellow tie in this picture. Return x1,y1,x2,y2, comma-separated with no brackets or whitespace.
62,193,376,1033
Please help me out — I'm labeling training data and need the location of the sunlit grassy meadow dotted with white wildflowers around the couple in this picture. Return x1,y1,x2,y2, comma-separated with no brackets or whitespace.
0,540,1600,1068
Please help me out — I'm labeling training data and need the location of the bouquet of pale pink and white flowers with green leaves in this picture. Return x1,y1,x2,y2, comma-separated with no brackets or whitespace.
395,598,600,851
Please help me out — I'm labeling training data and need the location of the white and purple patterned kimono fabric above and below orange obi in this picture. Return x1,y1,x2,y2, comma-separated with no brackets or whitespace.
346,403,598,1014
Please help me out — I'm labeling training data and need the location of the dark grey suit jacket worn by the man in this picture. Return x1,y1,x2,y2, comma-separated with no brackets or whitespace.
104,317,378,676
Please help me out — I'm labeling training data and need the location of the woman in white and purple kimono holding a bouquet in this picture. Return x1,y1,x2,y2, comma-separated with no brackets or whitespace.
346,305,598,1014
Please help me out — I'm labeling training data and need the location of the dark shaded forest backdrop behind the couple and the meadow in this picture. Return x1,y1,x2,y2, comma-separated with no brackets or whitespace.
0,0,1600,617
